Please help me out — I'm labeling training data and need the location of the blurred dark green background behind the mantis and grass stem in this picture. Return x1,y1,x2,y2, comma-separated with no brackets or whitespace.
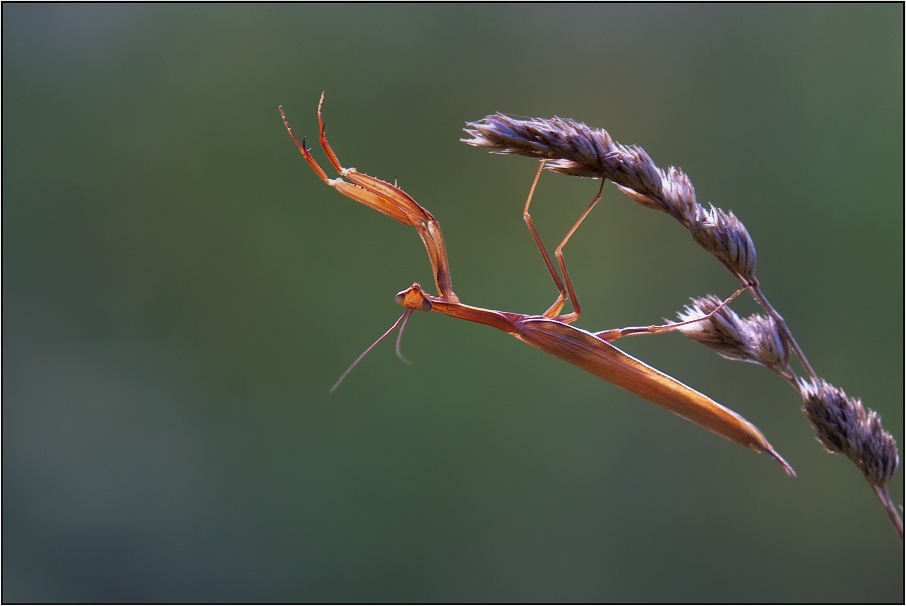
2,4,904,602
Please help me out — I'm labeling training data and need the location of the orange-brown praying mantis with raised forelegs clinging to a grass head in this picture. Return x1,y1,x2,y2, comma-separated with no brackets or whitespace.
279,95,795,475
